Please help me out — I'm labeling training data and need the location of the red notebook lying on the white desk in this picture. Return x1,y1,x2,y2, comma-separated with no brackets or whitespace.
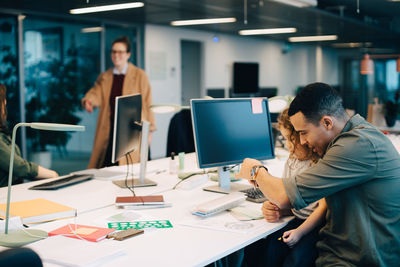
49,224,115,242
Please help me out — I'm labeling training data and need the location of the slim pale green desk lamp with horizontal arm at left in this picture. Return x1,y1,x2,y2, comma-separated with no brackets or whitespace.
0,122,85,247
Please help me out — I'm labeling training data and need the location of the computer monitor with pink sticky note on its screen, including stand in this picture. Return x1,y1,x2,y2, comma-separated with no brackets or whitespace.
190,98,275,193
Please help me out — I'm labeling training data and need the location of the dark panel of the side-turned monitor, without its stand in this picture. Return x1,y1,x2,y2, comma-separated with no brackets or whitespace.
111,94,142,163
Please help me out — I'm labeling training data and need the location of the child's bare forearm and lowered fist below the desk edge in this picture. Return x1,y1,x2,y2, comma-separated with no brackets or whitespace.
282,198,326,247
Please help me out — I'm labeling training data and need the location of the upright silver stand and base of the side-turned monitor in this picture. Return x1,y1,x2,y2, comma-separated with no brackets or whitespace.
113,121,157,188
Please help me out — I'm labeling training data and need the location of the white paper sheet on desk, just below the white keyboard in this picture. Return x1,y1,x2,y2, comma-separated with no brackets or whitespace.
179,212,268,234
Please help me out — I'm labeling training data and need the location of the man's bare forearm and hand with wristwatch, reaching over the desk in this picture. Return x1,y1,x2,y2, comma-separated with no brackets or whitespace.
237,158,291,209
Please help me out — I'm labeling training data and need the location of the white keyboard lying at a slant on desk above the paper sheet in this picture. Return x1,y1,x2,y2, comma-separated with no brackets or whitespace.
192,192,246,217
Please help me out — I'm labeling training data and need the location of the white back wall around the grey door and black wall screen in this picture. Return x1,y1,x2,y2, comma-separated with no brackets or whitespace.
144,24,339,158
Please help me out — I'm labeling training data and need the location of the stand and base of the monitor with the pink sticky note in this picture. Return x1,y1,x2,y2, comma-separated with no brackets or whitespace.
203,167,252,194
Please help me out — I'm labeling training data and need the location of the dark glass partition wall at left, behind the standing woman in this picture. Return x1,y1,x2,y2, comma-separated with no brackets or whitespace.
0,13,143,175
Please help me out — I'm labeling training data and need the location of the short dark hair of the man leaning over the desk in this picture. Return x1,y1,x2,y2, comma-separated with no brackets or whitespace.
289,83,346,125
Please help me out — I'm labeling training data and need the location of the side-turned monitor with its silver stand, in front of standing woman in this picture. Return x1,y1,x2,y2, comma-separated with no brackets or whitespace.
111,94,157,187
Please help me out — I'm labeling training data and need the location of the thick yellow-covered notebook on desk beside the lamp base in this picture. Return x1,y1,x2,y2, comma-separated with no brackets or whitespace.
0,198,76,224
